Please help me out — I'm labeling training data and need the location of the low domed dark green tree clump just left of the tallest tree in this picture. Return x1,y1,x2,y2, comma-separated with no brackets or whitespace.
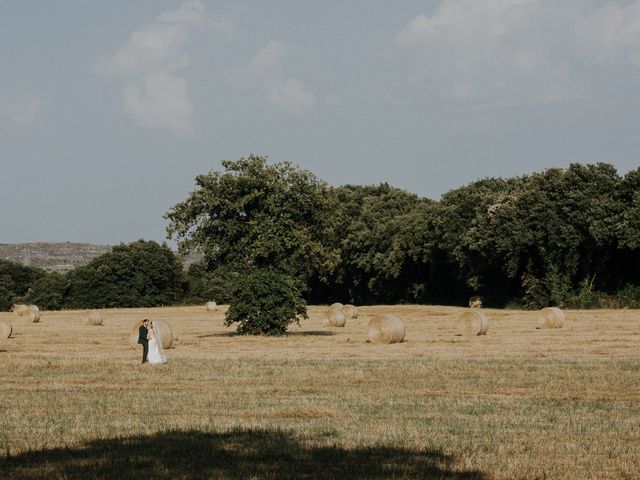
64,240,186,308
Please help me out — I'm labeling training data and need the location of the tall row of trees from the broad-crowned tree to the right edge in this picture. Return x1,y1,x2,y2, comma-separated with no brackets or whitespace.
167,156,640,308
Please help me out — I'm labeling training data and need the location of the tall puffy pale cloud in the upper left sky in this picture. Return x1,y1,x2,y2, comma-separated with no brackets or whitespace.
94,0,233,136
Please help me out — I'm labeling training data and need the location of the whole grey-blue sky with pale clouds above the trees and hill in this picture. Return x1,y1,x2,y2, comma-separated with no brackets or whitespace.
0,0,640,245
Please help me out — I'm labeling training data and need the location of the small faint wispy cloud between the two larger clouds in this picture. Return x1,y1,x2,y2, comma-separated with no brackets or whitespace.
230,41,316,113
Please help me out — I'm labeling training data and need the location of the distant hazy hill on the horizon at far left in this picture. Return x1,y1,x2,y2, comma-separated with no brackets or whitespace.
0,242,111,272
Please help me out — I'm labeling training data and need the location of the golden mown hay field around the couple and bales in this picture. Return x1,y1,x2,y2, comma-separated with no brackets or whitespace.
0,306,640,480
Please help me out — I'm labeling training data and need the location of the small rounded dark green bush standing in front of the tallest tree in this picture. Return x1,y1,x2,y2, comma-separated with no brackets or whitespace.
225,267,307,335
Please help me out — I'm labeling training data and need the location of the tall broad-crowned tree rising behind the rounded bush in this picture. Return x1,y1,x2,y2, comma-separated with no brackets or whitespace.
165,155,337,333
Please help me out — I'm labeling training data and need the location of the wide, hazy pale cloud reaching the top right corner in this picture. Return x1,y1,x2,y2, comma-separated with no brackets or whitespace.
396,0,640,109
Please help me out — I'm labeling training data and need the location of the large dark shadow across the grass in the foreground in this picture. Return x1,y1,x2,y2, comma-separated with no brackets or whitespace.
0,429,486,480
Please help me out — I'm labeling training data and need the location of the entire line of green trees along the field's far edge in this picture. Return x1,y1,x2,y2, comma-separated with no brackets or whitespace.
0,156,640,316
